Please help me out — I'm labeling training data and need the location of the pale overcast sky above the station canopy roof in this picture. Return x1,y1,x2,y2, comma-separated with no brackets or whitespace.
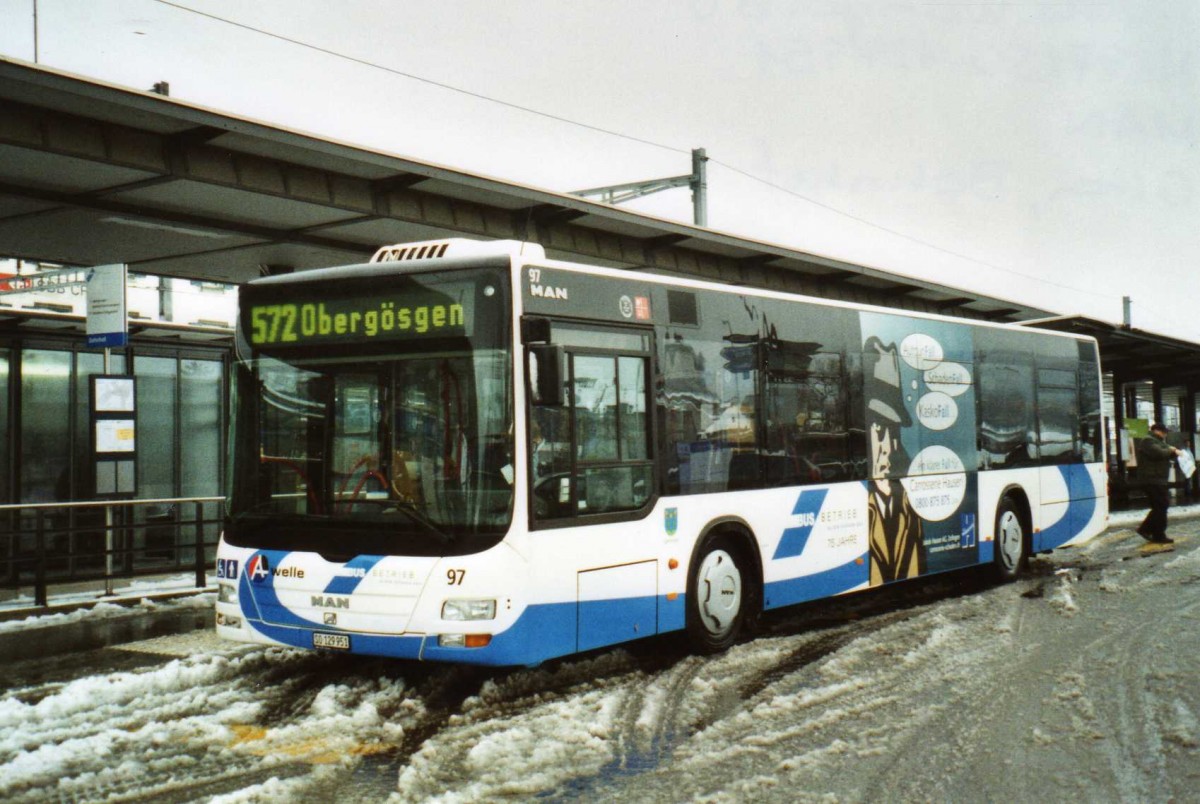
0,0,1200,341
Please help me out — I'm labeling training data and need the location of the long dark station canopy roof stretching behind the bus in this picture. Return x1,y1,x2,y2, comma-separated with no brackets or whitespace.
0,58,1195,386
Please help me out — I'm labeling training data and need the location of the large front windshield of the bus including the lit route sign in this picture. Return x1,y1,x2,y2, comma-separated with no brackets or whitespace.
230,271,512,553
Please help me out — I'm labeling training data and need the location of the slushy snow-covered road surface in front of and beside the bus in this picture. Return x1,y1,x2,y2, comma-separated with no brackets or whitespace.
0,517,1200,803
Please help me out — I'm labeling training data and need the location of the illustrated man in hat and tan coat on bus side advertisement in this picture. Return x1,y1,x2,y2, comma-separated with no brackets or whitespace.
863,336,925,587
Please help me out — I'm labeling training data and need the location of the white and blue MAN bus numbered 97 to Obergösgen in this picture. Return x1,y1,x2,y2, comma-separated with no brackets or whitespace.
216,239,1108,666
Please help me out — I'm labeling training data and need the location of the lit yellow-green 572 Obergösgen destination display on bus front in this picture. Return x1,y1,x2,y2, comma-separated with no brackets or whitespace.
241,283,475,348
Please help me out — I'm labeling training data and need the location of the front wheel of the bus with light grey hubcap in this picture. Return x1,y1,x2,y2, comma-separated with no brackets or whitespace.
688,533,757,654
